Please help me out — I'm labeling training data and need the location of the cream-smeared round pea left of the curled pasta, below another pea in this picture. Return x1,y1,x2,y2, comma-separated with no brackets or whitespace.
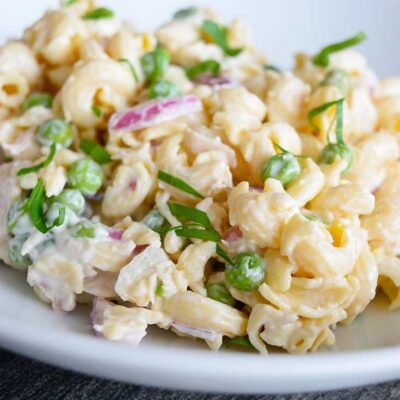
68,158,104,196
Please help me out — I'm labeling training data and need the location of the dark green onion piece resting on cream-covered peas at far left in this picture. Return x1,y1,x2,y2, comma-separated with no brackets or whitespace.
26,178,65,233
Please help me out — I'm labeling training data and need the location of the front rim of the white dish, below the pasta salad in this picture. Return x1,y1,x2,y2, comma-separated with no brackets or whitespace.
0,266,400,393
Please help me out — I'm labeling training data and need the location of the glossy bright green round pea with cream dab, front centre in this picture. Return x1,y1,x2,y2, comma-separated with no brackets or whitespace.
225,251,266,292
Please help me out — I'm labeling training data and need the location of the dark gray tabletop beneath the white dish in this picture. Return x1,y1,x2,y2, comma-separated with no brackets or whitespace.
0,349,400,400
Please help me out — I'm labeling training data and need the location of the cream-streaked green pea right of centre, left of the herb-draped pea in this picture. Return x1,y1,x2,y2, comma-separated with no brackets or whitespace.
261,153,301,187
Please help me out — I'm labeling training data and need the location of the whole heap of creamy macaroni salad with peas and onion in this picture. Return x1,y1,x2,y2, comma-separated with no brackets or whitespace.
0,0,400,353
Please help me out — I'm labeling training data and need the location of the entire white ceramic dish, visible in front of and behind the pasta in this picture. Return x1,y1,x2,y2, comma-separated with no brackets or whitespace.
0,0,400,393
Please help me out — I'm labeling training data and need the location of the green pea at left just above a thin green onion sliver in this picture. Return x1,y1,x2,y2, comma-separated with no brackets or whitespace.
39,118,74,147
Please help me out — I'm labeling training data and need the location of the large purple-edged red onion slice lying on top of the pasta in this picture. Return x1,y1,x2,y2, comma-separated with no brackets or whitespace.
109,95,203,132
